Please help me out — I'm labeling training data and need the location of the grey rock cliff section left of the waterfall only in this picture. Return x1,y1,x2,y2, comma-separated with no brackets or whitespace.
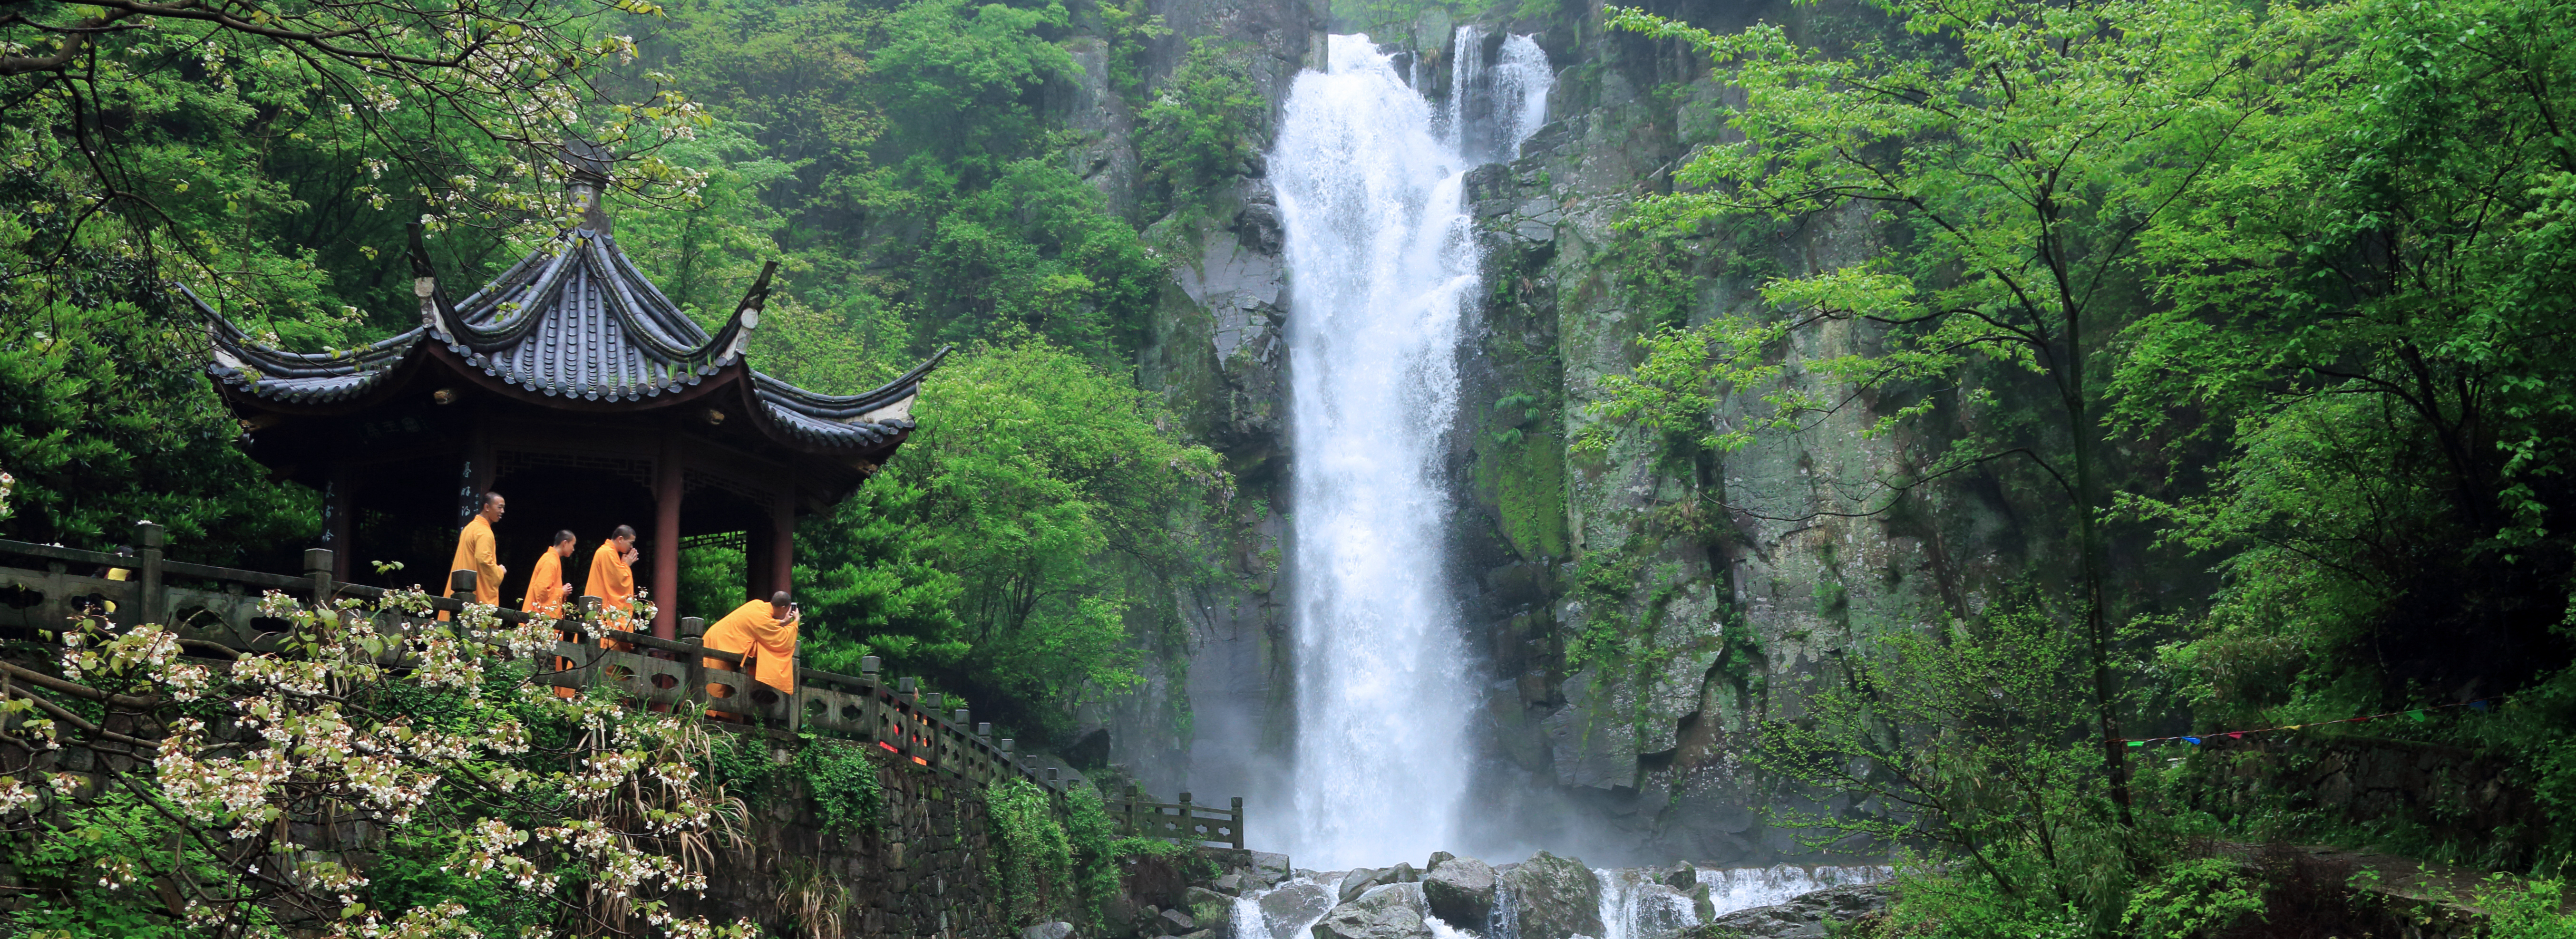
1061,0,1329,797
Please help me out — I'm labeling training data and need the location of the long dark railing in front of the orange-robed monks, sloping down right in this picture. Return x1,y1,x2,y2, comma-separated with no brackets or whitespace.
0,522,1244,849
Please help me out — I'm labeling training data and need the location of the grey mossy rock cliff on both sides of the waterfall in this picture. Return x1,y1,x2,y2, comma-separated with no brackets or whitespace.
1074,0,2020,864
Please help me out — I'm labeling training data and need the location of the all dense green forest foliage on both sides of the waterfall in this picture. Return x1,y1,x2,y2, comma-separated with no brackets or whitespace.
0,0,2576,937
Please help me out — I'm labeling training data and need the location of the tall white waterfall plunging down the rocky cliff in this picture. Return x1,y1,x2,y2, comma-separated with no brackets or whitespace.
1270,29,1546,867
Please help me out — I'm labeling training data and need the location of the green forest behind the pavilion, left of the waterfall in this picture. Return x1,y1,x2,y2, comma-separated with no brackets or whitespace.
0,0,1254,731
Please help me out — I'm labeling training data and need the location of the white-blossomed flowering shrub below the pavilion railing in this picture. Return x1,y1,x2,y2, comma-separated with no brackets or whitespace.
0,592,758,939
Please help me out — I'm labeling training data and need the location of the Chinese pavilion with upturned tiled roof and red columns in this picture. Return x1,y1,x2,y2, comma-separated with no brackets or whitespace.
191,175,945,638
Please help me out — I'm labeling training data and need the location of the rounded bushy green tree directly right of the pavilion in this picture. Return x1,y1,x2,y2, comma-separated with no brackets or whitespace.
798,339,1229,731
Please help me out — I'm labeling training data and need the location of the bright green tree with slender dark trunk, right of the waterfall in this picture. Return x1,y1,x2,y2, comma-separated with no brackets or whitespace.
1602,0,2318,818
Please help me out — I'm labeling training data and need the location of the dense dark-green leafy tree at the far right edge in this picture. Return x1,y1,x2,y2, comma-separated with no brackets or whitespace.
2118,2,2576,699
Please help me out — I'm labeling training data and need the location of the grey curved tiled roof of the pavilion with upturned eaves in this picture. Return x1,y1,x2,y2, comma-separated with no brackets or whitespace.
188,220,948,453
